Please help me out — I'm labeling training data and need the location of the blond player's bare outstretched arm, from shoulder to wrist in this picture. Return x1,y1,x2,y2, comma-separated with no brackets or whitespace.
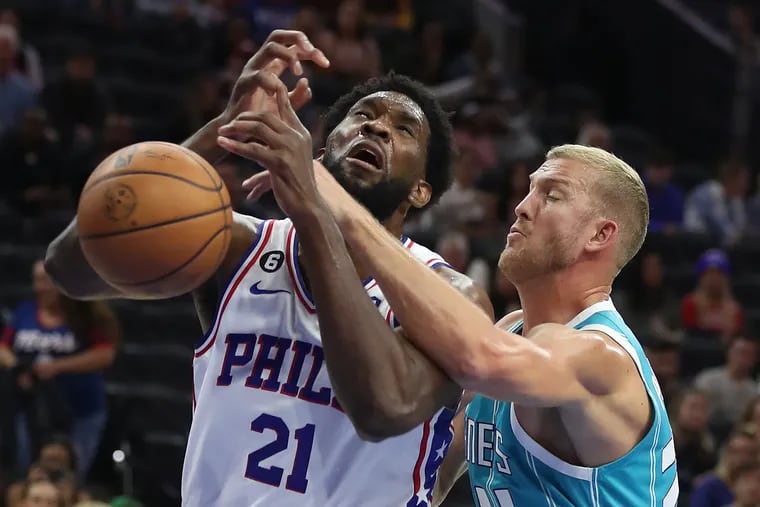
306,163,631,406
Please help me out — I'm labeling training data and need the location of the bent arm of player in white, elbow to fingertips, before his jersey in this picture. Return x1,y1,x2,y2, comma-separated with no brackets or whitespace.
220,78,492,441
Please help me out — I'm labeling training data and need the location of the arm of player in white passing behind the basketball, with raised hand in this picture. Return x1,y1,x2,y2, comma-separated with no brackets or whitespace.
45,30,329,308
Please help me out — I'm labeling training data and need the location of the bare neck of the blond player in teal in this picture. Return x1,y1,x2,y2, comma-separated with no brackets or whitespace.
517,272,612,334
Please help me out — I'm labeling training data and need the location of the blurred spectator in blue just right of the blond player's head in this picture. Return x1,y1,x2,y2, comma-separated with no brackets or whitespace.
643,148,684,233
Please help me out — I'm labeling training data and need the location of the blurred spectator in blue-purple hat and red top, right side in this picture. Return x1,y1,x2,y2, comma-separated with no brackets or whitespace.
681,249,744,342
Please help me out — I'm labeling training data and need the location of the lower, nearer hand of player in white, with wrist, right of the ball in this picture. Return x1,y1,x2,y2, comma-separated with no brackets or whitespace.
218,79,325,221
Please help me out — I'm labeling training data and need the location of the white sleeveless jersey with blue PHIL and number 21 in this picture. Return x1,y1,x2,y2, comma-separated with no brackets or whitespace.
182,220,454,507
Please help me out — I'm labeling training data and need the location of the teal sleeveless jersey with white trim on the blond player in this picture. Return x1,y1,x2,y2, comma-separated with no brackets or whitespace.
465,301,678,507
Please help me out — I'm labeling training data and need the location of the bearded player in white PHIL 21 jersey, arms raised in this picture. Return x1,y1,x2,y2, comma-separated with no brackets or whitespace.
46,32,493,507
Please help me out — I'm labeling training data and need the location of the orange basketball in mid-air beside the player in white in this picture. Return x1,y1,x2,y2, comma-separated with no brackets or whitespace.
77,141,232,298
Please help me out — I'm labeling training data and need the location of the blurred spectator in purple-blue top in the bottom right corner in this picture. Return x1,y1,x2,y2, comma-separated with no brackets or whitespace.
689,428,760,507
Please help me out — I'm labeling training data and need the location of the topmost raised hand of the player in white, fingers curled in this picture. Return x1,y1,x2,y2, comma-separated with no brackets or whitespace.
222,30,330,127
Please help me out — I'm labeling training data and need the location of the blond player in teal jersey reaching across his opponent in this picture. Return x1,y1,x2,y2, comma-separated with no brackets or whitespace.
240,106,678,507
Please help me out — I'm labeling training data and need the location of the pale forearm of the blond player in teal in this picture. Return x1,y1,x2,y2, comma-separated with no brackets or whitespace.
341,214,493,388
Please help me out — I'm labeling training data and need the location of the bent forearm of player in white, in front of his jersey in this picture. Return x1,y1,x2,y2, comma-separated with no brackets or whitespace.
296,211,448,439
